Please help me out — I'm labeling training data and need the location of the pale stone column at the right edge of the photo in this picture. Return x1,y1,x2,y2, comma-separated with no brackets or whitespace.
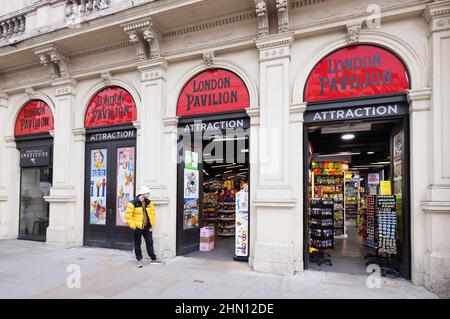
422,0,450,297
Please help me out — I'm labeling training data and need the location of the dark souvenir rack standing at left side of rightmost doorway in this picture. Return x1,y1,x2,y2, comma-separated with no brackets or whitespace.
309,198,334,266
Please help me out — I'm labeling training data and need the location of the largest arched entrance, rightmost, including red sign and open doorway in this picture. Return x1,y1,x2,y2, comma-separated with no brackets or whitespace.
304,44,411,278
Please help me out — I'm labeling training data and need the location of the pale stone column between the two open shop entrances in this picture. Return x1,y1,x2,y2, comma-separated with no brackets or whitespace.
251,33,301,274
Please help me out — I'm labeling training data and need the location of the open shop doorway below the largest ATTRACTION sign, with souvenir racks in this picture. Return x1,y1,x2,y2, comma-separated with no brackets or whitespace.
305,116,411,279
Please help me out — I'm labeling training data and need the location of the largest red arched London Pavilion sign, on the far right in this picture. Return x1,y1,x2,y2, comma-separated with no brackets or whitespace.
305,45,409,102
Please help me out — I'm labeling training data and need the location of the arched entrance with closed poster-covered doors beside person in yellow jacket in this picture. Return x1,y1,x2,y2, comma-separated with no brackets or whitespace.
84,86,137,249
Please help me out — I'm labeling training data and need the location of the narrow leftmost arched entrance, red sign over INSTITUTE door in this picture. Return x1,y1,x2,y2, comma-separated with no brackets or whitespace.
14,100,54,241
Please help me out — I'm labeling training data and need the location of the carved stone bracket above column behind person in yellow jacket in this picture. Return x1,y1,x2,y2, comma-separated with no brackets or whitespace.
122,19,162,61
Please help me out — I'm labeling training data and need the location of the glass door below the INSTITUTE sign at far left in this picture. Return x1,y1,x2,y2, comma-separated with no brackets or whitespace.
19,167,52,241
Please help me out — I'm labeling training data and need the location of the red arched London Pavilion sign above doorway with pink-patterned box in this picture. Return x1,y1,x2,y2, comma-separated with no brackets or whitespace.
177,69,250,116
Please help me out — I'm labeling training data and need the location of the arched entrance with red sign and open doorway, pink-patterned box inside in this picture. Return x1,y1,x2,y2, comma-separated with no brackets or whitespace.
177,68,250,261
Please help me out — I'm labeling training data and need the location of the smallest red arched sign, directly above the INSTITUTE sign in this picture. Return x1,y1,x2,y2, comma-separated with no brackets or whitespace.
14,100,54,136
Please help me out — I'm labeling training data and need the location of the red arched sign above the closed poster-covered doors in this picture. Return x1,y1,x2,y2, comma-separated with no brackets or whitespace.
84,87,137,128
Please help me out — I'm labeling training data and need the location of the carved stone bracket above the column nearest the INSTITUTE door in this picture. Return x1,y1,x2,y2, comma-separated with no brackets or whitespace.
34,45,69,80
